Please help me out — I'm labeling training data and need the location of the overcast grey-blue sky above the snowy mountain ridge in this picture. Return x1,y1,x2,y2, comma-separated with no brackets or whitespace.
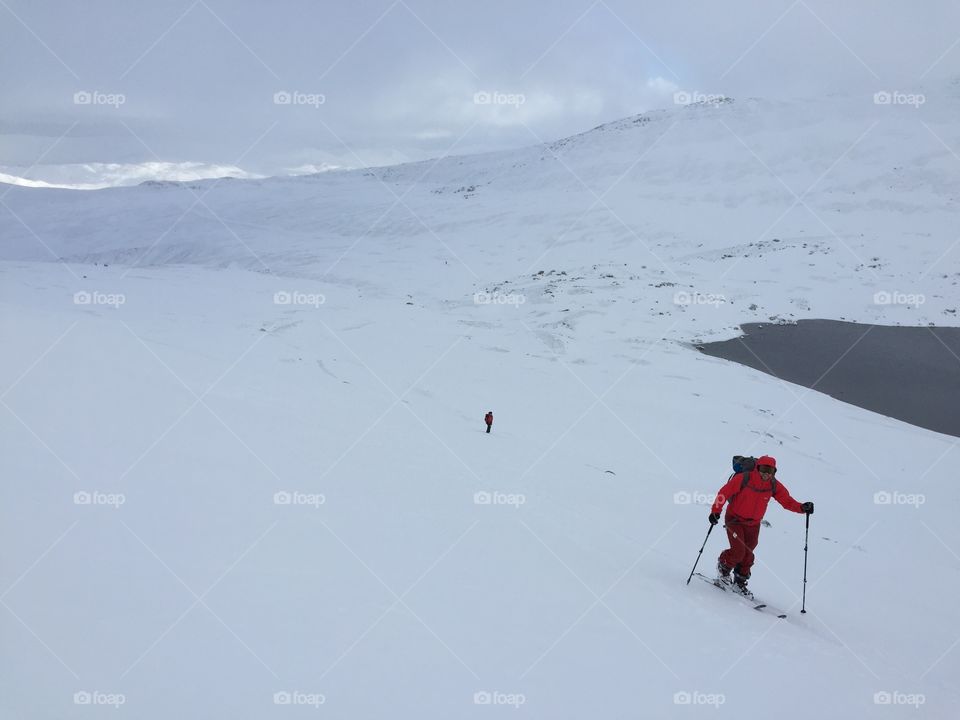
0,0,960,176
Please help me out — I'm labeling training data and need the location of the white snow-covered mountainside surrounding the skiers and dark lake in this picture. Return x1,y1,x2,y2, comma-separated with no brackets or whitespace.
0,91,960,718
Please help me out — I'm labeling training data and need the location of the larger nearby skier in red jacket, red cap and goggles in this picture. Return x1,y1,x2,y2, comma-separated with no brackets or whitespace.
709,455,813,597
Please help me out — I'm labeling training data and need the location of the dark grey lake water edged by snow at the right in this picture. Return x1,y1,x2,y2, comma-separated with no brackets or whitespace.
698,320,960,437
